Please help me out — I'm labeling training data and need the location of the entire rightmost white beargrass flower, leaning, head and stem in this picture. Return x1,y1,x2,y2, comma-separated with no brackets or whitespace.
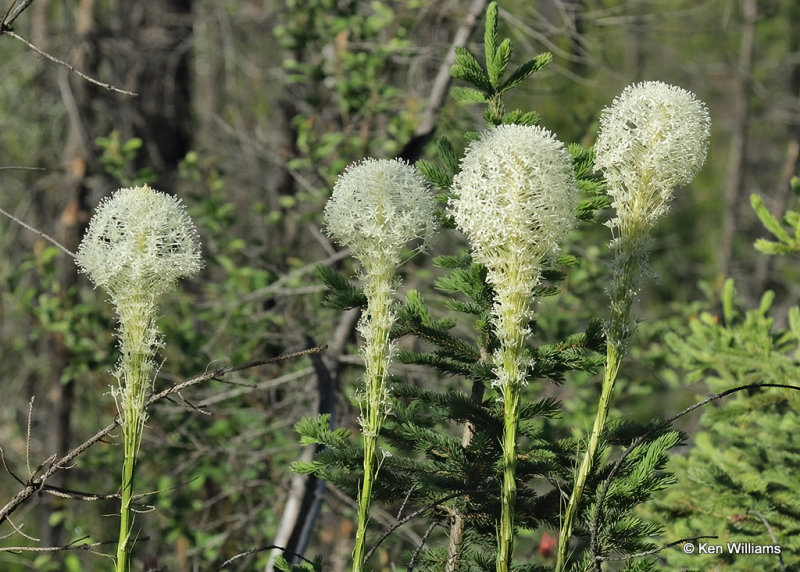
556,82,711,572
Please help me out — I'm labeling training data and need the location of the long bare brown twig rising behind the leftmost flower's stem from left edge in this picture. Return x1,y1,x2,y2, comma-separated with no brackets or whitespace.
0,346,325,524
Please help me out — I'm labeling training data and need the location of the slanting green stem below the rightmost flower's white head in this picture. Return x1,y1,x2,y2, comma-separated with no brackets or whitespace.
555,239,647,572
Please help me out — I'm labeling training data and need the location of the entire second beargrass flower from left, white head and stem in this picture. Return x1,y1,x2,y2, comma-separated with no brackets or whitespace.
325,159,436,572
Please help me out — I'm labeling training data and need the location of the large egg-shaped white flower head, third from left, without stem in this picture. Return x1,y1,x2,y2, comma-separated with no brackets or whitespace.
450,125,577,291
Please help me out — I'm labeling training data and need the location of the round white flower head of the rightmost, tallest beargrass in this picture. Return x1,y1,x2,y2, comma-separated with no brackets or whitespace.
595,81,711,238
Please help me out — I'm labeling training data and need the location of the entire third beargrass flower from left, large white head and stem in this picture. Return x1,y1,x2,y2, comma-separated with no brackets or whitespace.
450,125,577,572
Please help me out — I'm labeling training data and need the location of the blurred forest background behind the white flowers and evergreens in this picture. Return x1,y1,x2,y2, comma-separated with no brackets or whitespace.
0,0,800,571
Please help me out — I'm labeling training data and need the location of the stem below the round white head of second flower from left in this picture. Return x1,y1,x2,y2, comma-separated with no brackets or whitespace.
353,264,394,572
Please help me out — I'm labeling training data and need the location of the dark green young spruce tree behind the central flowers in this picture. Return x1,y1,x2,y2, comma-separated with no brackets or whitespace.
293,3,692,570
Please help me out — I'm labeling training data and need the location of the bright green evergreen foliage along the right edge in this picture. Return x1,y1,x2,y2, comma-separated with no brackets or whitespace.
653,188,800,571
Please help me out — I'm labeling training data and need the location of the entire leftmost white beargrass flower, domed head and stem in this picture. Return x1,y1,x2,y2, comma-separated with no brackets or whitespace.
76,186,202,572
